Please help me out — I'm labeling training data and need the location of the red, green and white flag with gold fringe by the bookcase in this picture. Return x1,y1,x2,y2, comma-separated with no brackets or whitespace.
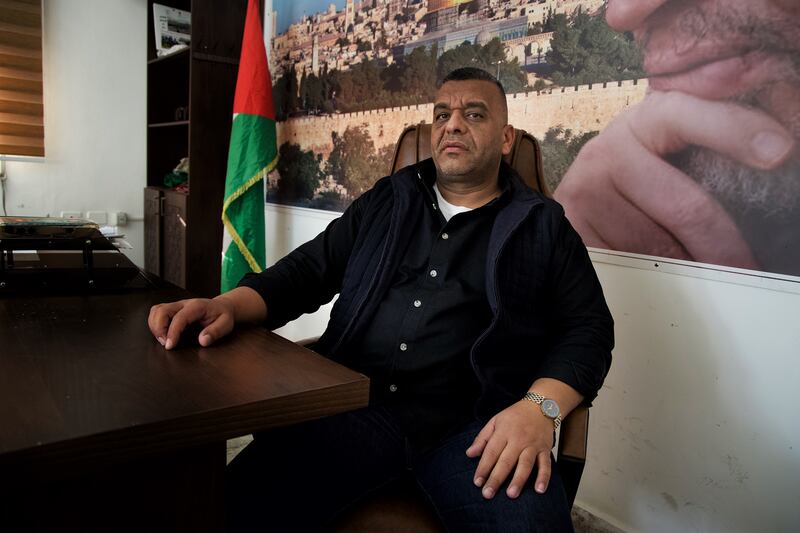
221,0,278,292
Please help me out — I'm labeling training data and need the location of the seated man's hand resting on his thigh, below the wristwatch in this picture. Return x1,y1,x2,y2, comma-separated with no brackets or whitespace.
467,400,555,499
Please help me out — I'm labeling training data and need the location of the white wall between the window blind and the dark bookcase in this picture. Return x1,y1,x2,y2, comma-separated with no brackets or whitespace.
6,0,147,265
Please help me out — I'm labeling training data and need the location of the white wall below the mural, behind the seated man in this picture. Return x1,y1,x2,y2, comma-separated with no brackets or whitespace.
266,206,800,532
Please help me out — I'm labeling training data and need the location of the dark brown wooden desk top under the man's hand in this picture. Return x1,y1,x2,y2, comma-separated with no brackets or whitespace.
0,288,369,475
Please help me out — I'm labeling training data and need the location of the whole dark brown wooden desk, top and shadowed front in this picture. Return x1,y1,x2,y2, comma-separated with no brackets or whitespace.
0,289,369,532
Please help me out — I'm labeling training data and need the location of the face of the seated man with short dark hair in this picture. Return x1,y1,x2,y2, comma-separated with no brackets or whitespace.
431,80,514,184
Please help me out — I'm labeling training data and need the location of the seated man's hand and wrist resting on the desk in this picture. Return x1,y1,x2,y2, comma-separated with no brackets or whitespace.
147,287,267,350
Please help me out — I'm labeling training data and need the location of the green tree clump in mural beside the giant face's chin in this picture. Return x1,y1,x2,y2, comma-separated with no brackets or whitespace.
547,13,645,86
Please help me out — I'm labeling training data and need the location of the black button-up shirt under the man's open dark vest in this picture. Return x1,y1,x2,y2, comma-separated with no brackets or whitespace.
354,174,508,446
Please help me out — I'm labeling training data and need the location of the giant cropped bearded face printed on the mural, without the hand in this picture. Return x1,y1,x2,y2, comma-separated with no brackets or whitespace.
606,0,800,215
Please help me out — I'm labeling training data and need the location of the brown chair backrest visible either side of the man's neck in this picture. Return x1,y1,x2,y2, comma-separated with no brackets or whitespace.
390,122,550,196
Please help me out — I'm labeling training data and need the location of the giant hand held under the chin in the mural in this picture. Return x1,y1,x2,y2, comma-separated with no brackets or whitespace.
554,91,794,268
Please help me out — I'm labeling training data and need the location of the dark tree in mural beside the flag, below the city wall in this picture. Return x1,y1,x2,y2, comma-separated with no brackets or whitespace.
276,142,322,203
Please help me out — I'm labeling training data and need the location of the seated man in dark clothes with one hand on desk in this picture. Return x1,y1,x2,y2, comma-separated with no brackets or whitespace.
149,68,613,533
